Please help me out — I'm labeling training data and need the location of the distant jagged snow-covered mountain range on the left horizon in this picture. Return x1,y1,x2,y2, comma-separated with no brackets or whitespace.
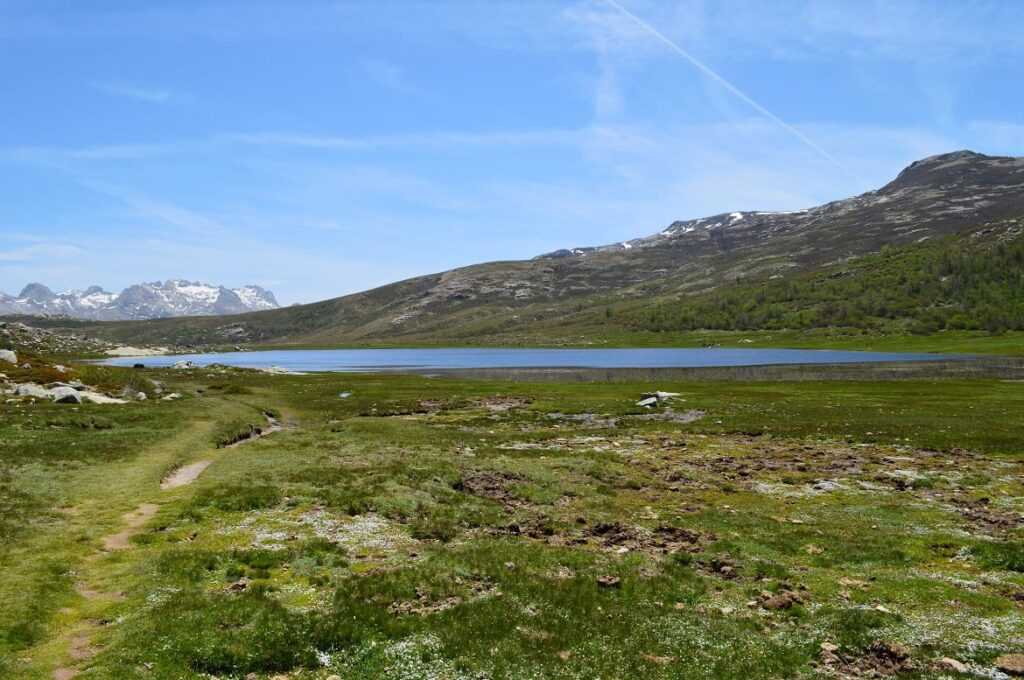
0,279,280,321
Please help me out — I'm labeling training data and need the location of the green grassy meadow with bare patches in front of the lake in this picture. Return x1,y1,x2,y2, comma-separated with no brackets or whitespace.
0,369,1024,680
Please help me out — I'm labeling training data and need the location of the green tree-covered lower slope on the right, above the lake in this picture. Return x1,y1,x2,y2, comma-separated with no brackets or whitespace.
629,228,1024,334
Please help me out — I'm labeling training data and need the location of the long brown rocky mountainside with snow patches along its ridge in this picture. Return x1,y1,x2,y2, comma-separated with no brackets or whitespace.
22,151,1024,345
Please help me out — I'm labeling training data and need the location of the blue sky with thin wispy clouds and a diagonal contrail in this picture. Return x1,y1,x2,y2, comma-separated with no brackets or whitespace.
0,0,1024,303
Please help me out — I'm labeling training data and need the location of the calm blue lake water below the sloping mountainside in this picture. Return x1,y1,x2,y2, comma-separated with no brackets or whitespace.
96,347,968,371
